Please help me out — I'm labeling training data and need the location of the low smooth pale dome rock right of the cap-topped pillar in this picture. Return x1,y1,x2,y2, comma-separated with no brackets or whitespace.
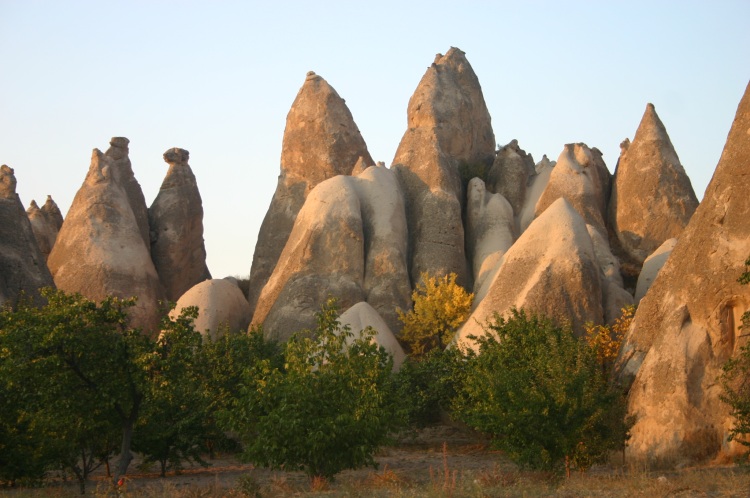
170,278,250,339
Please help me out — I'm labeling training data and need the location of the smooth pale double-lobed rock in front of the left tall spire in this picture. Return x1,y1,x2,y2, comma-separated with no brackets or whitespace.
253,166,411,340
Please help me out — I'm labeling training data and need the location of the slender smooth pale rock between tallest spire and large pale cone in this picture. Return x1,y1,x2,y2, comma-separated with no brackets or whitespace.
466,178,515,303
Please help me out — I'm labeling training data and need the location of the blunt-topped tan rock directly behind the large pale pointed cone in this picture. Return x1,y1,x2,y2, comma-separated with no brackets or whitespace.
535,143,611,234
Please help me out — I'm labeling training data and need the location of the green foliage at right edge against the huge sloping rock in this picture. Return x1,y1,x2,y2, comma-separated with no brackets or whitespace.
719,258,750,456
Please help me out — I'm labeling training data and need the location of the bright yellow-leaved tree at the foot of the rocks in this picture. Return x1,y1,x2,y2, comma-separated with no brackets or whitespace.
396,273,474,357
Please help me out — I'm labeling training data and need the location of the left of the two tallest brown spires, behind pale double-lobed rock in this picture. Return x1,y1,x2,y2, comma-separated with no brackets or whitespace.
248,71,374,318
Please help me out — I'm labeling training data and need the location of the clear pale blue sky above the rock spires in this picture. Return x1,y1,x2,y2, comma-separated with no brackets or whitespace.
0,0,750,277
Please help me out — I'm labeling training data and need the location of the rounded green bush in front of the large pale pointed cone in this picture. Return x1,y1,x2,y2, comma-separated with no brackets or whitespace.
454,309,629,470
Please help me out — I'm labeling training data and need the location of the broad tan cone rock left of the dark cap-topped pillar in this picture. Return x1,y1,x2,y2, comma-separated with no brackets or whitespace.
48,149,164,333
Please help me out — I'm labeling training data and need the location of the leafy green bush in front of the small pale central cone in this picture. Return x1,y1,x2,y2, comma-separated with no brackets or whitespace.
229,300,397,478
